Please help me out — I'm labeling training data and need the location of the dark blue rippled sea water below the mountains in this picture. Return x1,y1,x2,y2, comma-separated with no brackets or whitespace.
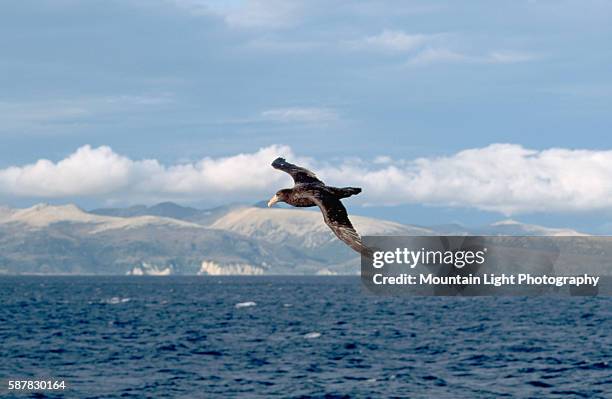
0,277,612,398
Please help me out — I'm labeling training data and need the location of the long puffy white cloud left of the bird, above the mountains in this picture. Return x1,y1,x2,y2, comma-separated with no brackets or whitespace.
0,146,294,200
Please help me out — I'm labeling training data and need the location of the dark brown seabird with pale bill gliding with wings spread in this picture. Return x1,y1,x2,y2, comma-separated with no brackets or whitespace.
268,158,371,256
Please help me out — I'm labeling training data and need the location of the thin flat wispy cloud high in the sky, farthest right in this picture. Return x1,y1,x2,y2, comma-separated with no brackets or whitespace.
408,47,537,66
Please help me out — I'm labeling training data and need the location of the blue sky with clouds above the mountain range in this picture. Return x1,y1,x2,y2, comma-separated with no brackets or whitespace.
0,0,612,234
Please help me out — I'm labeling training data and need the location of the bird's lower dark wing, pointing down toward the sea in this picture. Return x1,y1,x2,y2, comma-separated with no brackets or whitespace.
313,195,372,258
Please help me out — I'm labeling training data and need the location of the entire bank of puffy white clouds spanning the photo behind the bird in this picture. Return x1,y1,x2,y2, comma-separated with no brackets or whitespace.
0,144,612,215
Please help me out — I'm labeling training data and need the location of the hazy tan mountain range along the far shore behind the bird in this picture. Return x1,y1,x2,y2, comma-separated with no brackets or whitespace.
0,202,581,275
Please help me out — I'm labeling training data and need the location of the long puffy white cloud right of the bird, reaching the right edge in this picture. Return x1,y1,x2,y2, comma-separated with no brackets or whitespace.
321,144,612,215
